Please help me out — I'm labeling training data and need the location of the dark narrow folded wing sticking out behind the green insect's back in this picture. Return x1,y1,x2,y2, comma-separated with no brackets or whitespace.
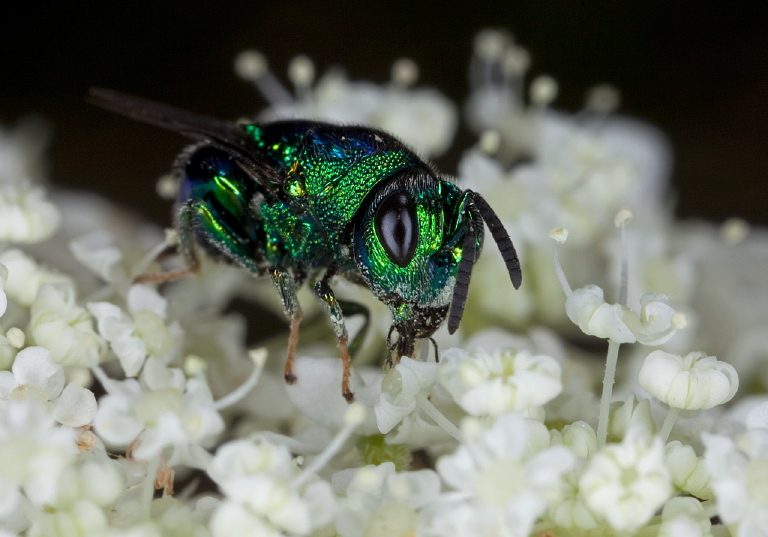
86,88,282,187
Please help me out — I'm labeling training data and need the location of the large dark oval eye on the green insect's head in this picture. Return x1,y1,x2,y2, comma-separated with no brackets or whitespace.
374,192,419,267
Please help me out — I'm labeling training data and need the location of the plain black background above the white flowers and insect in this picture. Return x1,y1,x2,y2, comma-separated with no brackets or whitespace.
0,0,768,224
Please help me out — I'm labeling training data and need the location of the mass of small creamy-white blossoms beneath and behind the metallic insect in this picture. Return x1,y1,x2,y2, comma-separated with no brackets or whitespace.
0,31,768,537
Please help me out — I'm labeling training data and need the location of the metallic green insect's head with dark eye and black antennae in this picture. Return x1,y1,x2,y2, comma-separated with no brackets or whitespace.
353,170,520,355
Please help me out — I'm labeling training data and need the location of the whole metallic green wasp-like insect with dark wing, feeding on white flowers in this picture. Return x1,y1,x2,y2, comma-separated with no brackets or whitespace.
90,89,522,401
